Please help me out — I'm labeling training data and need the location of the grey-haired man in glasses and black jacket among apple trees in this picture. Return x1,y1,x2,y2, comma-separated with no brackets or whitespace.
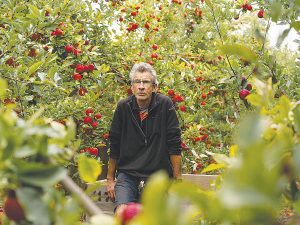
106,63,182,215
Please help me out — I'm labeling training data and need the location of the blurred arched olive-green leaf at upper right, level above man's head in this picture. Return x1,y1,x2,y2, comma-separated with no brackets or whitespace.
220,44,257,63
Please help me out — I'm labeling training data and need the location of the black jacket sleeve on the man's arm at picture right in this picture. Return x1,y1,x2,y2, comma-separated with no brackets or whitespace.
167,99,182,155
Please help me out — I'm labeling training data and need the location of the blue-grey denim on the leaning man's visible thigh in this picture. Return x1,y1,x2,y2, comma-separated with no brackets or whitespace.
114,173,144,211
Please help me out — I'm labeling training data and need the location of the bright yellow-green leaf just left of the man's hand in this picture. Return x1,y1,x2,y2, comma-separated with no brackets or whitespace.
78,154,102,183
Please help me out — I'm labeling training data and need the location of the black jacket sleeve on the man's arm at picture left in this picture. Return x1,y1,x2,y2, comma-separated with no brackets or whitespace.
109,104,122,159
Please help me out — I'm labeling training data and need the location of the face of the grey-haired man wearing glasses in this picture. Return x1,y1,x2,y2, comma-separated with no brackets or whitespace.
131,72,157,104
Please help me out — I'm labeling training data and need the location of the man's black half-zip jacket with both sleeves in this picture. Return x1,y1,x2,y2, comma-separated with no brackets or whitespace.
109,93,182,178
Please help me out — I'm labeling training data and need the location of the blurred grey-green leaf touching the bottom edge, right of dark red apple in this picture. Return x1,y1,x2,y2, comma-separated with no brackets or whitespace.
16,187,51,225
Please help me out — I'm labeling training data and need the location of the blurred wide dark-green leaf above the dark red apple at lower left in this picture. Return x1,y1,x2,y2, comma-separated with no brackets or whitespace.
18,162,67,187
